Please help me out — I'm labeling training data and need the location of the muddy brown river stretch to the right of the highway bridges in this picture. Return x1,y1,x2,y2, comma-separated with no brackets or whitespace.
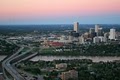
31,56,120,62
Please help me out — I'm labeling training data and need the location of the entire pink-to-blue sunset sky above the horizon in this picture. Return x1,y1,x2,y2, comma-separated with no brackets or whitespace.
0,0,120,24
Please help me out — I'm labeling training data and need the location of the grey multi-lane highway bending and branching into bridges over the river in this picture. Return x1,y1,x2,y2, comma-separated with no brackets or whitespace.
2,47,37,80
